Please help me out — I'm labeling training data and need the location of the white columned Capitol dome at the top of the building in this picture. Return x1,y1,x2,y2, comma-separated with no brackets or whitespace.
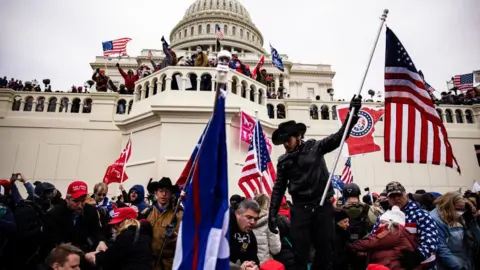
170,0,265,54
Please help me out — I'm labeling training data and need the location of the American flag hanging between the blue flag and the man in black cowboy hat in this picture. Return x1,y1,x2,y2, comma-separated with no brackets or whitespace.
238,121,277,198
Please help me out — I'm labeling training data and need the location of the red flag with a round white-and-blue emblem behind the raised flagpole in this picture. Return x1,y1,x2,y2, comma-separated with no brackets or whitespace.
337,105,384,157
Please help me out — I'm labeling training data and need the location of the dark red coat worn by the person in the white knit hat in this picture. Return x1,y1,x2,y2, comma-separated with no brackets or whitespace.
349,227,421,270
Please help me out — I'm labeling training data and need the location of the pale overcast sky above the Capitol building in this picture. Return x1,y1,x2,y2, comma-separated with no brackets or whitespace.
0,0,480,98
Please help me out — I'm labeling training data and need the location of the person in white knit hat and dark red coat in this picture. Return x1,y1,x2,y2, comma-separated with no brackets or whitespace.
349,206,420,270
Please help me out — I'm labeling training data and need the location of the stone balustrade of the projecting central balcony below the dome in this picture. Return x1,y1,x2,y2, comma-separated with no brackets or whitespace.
135,66,267,105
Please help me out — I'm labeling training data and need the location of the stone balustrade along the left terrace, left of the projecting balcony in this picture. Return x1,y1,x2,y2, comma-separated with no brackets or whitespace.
0,88,133,119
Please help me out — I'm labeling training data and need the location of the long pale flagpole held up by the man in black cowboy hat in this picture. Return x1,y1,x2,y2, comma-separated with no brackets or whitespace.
320,9,388,206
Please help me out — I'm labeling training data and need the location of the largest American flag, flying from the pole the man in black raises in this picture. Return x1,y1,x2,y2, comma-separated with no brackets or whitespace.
384,27,460,172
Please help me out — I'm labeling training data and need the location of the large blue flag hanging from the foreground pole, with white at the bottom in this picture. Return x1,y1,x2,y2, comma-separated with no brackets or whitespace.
173,91,230,270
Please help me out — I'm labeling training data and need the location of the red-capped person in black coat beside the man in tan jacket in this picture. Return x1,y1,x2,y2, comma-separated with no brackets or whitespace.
85,207,152,270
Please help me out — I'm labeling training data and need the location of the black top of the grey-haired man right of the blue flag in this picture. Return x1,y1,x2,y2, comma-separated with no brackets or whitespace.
229,210,260,265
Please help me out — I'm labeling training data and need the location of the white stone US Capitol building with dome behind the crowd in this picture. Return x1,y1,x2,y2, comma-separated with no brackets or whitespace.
0,0,480,195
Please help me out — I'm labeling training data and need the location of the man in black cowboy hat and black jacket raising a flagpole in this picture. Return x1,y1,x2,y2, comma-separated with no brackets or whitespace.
268,96,362,270
